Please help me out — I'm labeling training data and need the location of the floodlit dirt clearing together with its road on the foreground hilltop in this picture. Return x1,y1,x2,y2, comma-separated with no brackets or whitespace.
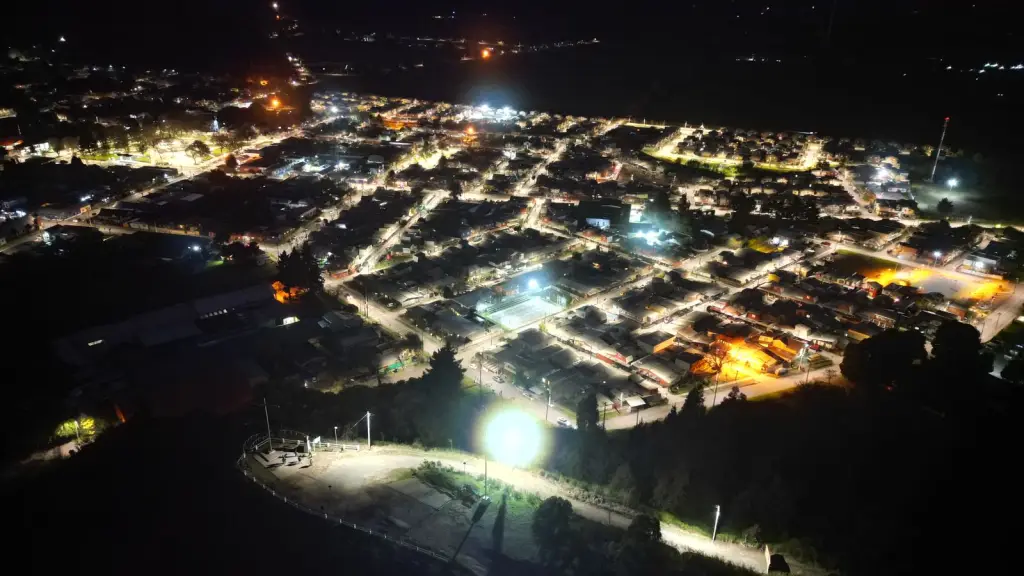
245,448,798,574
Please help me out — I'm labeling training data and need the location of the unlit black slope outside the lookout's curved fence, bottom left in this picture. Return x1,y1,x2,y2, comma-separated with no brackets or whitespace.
2,410,461,574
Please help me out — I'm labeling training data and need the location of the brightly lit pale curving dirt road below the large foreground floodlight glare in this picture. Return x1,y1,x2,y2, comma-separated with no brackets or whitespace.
318,448,770,573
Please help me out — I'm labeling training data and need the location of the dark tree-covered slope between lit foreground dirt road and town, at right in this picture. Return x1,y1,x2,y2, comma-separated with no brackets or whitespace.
547,323,1020,574
